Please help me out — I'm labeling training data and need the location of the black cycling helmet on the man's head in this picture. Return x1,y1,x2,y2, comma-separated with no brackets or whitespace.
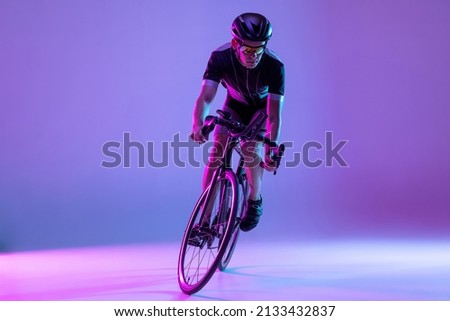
231,13,272,41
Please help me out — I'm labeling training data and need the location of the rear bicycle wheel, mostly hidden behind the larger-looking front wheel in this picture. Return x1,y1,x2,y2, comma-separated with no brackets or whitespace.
219,176,249,271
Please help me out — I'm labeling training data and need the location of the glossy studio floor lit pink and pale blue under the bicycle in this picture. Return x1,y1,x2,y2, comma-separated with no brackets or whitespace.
0,240,450,301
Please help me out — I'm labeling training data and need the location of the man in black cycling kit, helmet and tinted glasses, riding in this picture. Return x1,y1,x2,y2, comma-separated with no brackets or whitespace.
191,13,285,231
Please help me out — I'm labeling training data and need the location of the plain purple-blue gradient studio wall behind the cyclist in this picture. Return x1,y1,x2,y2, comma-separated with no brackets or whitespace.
0,0,450,251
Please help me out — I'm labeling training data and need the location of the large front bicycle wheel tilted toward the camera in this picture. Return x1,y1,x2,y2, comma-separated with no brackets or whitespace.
178,170,238,294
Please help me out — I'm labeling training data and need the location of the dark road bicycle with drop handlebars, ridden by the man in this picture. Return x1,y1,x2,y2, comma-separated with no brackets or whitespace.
178,110,285,294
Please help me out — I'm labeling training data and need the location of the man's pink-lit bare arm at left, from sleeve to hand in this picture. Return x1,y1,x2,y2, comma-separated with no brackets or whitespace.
192,79,219,143
